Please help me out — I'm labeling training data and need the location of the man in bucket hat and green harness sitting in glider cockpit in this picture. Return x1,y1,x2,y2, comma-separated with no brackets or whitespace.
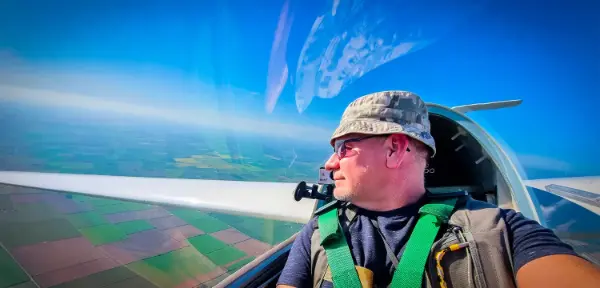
278,91,600,287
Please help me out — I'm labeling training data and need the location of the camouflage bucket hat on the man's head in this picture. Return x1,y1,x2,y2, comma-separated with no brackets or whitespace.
331,91,436,157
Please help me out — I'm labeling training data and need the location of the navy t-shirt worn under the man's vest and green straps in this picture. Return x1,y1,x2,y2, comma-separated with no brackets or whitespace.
278,198,577,287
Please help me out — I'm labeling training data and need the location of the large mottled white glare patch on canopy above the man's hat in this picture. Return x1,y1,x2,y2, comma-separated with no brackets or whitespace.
295,1,433,112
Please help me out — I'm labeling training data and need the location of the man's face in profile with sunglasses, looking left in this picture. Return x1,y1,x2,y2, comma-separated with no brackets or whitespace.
325,134,389,201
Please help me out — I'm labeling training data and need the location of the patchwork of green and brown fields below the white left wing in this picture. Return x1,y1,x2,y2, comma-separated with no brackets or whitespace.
0,185,302,288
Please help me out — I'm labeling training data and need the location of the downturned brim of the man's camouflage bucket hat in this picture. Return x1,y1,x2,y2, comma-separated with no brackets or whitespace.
330,119,436,157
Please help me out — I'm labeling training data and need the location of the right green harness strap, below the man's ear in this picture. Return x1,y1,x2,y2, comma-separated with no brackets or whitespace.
390,197,457,288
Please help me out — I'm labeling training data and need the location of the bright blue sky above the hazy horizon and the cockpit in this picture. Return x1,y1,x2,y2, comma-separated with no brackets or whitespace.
0,1,600,176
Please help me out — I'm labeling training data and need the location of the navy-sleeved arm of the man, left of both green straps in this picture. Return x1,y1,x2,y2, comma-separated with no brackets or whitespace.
277,218,316,288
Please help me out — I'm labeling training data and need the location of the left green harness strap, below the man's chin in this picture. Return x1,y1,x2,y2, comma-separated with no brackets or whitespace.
318,209,362,288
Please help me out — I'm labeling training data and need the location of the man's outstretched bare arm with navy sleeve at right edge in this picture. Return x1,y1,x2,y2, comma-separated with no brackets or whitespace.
505,210,600,288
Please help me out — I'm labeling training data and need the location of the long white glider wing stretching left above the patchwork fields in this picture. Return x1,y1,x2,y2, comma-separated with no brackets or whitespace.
0,171,316,223
